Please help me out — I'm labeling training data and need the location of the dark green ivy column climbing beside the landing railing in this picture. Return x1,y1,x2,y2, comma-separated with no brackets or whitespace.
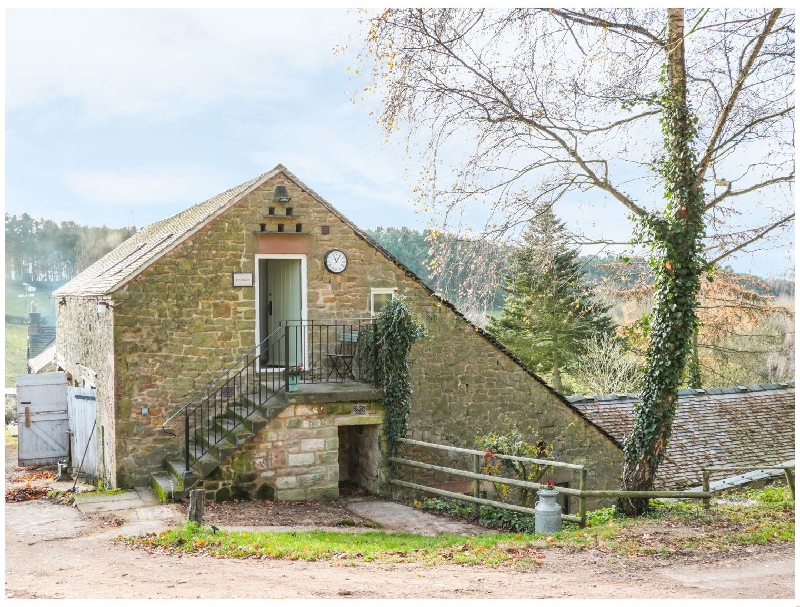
375,295,426,457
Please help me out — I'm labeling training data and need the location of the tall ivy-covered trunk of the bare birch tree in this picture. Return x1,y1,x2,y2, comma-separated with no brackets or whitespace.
618,14,706,515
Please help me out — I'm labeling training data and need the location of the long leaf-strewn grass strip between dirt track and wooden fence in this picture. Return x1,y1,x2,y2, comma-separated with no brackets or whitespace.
122,487,794,569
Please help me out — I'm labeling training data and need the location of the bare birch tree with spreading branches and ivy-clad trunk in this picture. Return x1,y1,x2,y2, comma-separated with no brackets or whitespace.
366,8,794,514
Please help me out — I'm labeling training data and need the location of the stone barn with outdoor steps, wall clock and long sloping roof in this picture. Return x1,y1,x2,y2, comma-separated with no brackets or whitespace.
54,165,622,500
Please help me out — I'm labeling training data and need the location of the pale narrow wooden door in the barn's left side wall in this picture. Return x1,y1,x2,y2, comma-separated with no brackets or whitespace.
67,388,100,483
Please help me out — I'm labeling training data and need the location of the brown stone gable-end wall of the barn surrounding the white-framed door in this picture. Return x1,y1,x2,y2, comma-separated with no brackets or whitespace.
69,169,622,495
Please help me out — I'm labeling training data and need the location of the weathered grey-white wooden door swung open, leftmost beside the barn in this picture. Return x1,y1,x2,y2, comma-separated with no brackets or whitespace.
17,373,69,466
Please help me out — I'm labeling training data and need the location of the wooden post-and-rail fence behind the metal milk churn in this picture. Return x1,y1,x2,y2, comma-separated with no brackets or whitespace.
389,438,724,527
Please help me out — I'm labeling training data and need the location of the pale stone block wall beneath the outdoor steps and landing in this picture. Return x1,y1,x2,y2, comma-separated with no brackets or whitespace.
208,394,385,501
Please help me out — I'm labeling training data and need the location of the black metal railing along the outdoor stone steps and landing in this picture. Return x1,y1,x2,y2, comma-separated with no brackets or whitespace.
162,319,376,476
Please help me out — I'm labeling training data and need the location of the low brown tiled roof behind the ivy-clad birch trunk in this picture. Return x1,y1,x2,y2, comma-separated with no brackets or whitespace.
567,383,794,489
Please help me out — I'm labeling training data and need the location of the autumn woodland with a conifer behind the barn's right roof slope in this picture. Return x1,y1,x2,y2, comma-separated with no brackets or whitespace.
368,226,794,394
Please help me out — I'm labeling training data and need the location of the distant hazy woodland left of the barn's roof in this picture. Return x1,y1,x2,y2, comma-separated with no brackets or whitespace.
6,213,136,282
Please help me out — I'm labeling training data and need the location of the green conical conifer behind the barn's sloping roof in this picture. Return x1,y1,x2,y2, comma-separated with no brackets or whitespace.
488,208,614,391
